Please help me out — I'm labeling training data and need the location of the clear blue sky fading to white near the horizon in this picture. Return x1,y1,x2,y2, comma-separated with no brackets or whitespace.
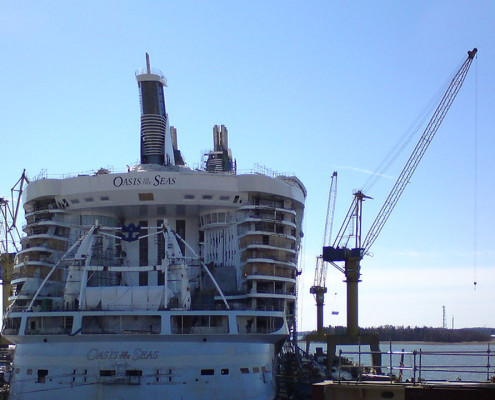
0,0,495,329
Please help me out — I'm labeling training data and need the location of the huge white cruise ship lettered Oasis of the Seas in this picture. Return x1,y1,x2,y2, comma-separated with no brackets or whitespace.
2,55,306,400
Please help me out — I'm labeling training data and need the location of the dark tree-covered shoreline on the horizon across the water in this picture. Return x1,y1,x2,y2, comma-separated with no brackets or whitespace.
309,325,495,343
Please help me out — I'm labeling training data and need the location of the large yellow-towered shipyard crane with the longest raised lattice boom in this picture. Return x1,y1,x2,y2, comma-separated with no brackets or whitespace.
323,48,478,336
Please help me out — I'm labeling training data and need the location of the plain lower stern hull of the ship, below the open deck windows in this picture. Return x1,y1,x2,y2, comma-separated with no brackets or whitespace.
4,312,287,400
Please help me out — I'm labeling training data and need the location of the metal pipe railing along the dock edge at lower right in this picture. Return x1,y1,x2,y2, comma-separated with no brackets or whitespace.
337,344,495,384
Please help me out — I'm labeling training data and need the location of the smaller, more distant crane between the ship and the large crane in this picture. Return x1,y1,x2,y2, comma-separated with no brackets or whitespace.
309,171,337,334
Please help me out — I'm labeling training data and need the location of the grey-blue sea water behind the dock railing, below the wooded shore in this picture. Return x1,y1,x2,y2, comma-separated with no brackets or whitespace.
299,341,495,382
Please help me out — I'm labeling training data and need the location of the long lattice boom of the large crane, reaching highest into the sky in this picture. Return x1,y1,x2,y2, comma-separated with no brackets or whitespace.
362,48,478,253
